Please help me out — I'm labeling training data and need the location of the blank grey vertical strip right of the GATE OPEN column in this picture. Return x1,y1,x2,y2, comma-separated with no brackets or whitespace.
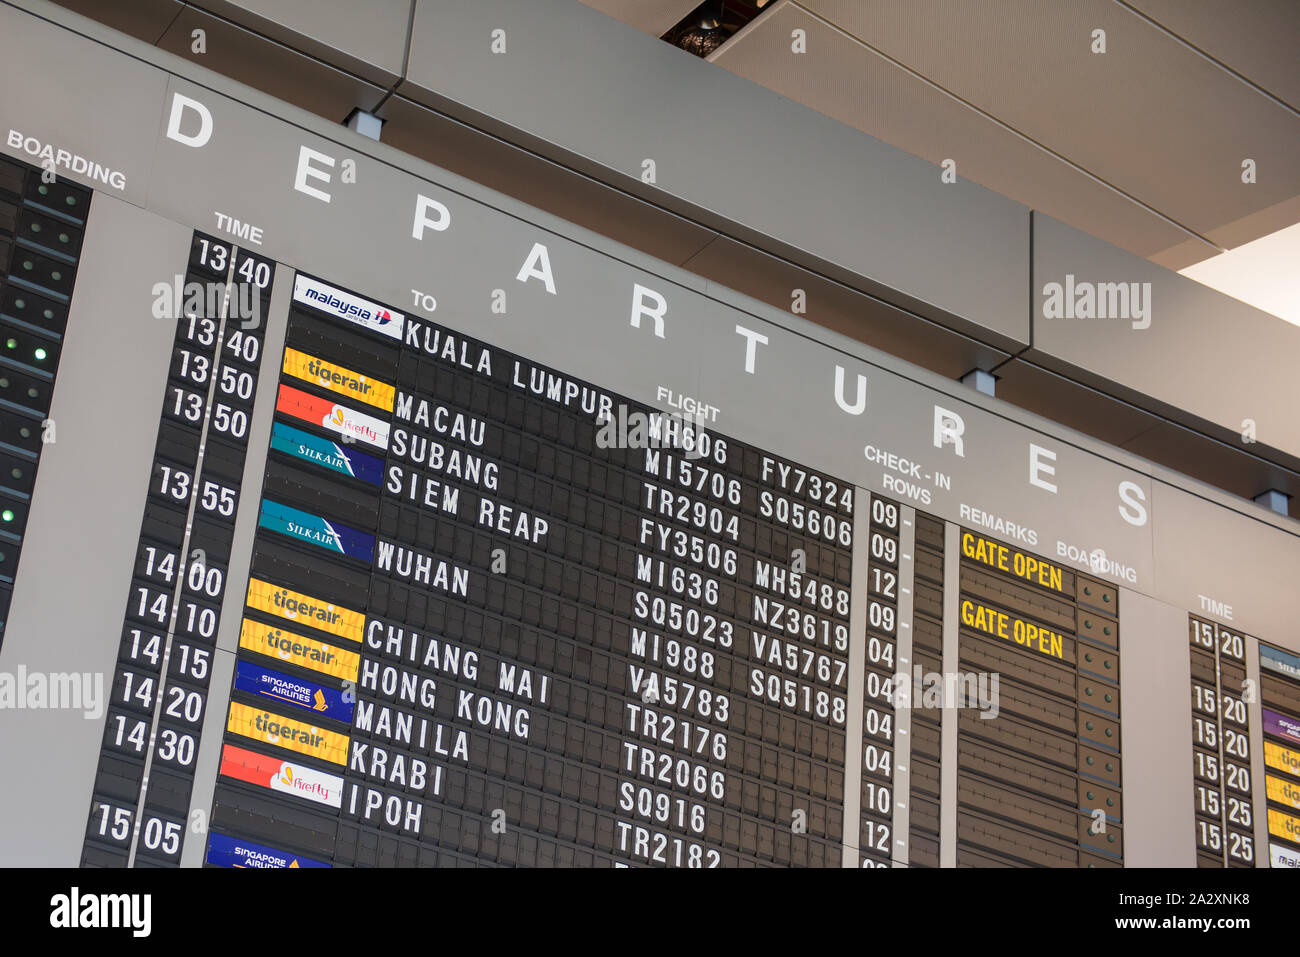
1119,589,1196,867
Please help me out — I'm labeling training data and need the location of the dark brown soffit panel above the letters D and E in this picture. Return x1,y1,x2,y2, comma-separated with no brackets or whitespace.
157,7,384,122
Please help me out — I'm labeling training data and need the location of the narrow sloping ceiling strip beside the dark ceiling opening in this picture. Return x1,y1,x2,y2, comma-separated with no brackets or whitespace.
711,4,1218,265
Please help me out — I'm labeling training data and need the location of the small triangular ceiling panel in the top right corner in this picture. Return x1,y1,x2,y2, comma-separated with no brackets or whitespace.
1122,0,1300,109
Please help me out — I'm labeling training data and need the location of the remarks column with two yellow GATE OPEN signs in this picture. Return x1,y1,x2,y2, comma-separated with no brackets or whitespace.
957,529,1123,867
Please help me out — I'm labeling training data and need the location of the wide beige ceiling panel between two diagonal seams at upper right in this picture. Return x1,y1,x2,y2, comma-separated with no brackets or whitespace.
801,0,1300,244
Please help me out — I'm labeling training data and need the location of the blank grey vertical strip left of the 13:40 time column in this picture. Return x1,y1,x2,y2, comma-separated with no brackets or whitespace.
0,195,190,867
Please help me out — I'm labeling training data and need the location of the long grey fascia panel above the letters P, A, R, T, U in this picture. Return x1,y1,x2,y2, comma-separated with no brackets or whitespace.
399,0,1028,345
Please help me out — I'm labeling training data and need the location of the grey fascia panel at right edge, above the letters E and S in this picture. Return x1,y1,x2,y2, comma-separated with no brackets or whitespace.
1028,213,1300,470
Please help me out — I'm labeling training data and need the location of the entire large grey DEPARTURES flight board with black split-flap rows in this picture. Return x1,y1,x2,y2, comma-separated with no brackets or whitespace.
0,5,1300,869
